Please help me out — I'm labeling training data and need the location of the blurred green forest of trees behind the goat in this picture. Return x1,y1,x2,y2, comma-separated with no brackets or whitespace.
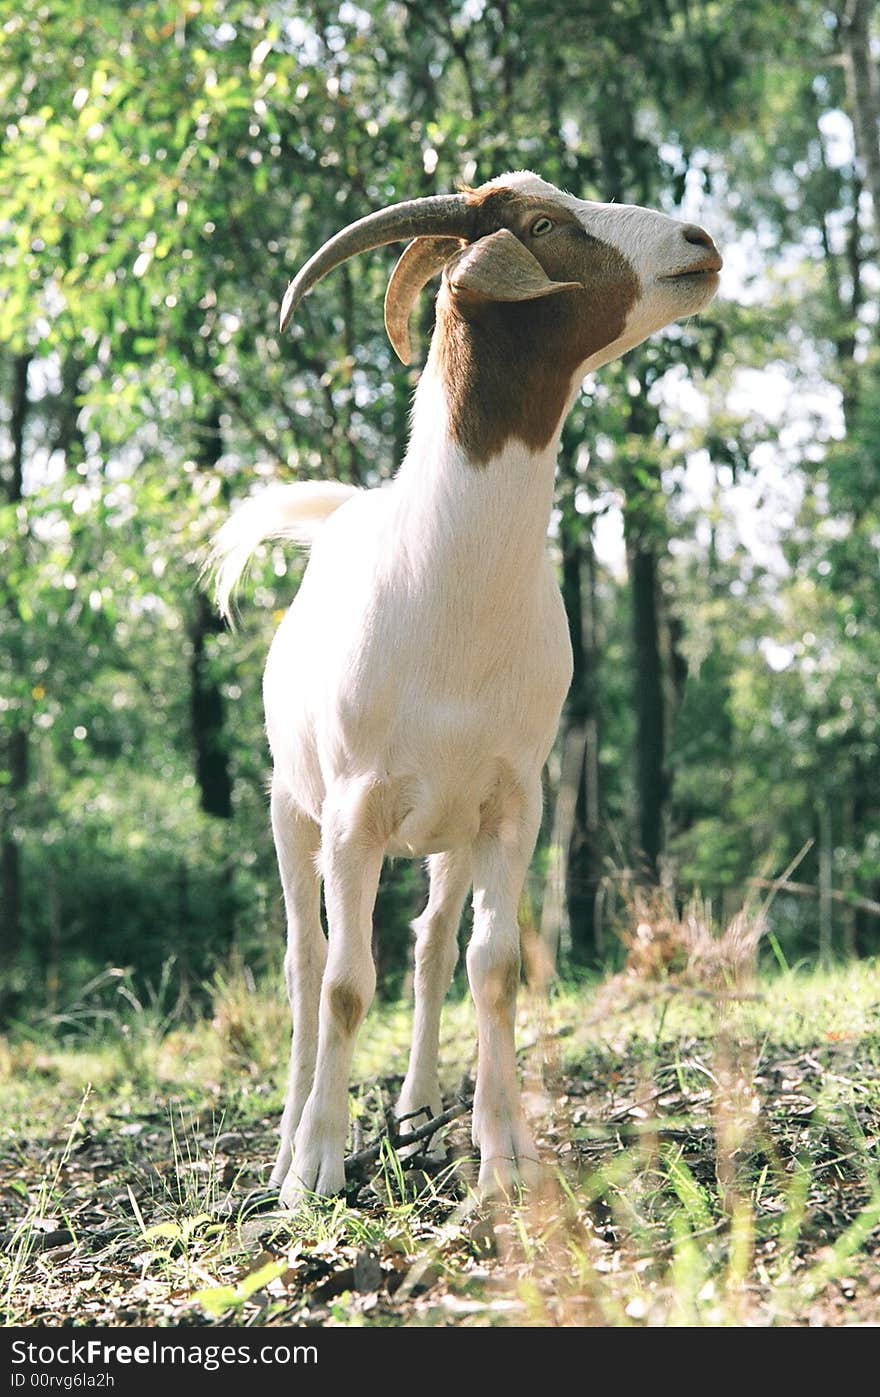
0,0,880,1014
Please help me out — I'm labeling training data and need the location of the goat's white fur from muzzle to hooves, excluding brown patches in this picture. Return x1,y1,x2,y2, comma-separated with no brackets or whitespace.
218,173,714,1204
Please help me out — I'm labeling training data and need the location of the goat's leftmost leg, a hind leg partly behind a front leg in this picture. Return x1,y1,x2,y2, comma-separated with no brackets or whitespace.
271,781,327,1187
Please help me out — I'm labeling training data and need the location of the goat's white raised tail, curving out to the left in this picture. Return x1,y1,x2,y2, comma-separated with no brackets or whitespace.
207,481,358,616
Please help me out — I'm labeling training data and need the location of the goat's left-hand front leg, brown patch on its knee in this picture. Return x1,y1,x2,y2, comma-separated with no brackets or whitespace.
281,792,384,1207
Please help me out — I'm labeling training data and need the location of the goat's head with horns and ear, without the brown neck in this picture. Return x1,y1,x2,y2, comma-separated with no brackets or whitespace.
281,170,721,369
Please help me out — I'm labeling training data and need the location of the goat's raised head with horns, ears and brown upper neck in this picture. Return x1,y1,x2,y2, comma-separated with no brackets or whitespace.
281,170,721,458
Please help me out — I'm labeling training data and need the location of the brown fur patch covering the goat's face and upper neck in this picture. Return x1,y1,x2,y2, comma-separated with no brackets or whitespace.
437,189,640,465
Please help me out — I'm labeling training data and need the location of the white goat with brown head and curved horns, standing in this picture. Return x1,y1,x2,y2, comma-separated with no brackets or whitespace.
215,172,721,1206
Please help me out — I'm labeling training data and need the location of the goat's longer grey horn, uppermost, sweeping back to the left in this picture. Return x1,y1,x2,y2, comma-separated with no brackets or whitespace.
281,194,475,330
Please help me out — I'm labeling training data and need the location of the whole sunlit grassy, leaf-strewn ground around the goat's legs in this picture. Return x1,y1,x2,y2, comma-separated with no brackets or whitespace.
0,946,880,1327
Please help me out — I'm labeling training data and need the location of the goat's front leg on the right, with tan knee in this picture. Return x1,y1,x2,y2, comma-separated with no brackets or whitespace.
468,784,541,1194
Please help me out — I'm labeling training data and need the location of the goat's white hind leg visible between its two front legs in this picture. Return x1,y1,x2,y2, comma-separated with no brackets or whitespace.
395,849,472,1148
